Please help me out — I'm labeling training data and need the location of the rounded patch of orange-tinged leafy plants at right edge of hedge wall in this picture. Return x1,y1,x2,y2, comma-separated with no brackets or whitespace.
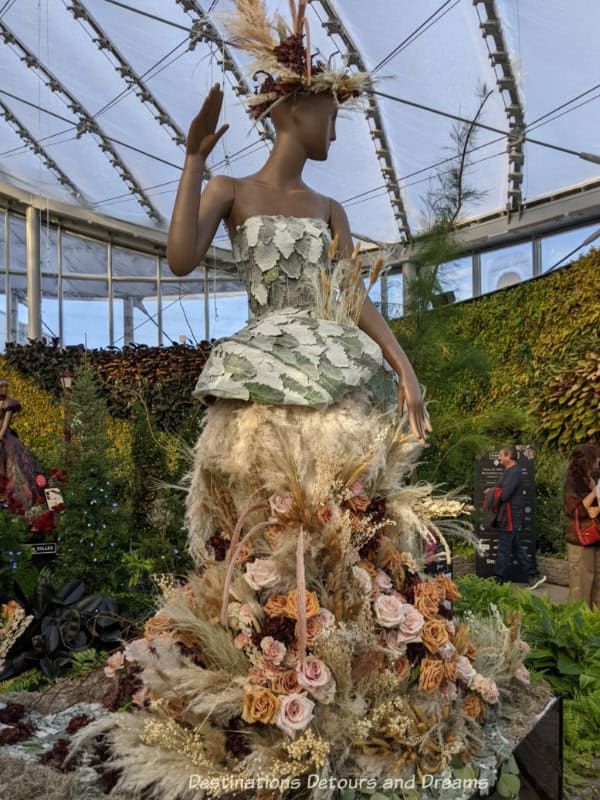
537,353,600,448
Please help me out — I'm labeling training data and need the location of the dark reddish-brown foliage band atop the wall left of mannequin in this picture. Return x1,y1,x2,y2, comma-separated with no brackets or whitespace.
6,340,211,431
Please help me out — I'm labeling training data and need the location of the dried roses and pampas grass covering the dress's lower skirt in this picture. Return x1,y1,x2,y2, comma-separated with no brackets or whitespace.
70,409,528,800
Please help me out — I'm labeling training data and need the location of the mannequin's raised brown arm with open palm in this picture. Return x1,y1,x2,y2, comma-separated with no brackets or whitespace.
167,83,233,275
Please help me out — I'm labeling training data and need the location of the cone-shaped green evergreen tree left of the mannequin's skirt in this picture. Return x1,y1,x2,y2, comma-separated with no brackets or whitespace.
53,364,131,593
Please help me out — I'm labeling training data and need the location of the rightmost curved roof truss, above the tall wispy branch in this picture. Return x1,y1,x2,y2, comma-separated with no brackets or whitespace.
473,0,526,212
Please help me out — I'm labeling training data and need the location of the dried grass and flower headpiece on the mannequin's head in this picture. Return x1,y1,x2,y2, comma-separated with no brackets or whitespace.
225,0,370,118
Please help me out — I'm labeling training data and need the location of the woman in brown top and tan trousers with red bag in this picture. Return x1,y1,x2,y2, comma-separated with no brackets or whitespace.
563,444,600,608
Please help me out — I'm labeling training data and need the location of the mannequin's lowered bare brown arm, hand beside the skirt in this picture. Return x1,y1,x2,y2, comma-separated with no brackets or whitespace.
329,201,431,444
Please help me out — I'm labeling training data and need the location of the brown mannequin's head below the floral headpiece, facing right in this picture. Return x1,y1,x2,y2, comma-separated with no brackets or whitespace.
271,93,337,161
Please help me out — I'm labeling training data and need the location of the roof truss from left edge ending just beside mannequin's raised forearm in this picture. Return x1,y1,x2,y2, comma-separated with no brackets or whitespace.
0,19,163,222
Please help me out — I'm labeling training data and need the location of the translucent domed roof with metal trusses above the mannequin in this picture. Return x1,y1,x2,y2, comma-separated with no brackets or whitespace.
0,0,600,247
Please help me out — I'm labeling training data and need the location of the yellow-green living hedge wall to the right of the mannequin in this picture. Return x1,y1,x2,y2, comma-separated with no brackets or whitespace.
392,249,600,447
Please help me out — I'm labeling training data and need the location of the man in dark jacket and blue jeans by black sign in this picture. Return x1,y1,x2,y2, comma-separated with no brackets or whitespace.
487,445,546,589
